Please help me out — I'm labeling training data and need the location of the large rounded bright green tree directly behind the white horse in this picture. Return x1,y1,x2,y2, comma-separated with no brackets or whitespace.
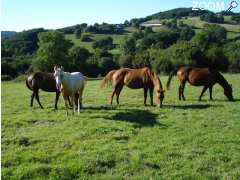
33,31,73,72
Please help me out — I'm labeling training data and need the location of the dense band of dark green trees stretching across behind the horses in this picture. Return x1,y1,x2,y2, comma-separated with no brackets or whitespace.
2,7,240,77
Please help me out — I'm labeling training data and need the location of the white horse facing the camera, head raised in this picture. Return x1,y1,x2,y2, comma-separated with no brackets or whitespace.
54,66,86,114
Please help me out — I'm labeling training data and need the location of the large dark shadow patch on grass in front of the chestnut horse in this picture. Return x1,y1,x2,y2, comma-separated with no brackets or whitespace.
109,109,167,127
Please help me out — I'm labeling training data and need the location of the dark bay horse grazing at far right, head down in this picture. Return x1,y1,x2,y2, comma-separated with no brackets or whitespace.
167,67,233,101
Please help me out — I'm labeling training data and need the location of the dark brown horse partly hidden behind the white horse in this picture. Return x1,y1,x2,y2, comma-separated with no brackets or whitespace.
26,72,60,109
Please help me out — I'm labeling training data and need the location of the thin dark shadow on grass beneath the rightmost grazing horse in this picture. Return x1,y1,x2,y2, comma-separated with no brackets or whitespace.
163,104,223,109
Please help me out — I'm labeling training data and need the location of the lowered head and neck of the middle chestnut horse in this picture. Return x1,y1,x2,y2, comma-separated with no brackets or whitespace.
153,73,165,107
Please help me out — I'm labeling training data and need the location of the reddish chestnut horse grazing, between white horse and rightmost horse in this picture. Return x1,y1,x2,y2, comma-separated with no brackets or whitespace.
101,67,164,107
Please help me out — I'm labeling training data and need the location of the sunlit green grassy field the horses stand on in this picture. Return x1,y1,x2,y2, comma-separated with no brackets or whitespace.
2,74,240,179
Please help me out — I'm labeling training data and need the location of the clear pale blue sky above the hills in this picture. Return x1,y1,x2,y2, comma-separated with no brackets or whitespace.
1,0,240,31
